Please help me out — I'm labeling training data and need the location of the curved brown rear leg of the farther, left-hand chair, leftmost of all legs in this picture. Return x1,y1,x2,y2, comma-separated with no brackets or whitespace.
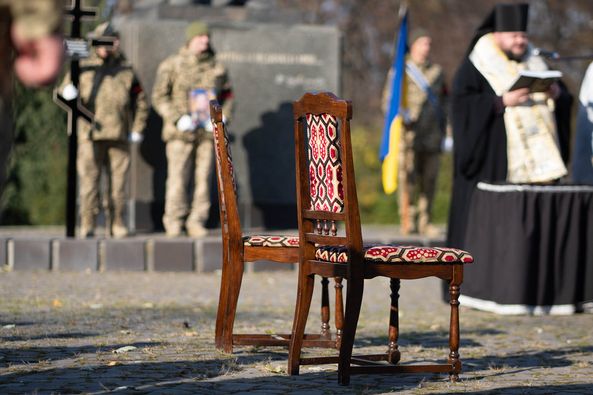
222,256,245,353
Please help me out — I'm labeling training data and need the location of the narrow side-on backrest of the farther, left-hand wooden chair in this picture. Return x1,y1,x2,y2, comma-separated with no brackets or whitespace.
210,100,242,250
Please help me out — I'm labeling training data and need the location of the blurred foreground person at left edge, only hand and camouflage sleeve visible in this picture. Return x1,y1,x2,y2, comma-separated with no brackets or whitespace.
0,0,63,210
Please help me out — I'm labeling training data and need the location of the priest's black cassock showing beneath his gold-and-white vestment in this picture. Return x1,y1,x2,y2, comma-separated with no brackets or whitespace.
447,57,572,248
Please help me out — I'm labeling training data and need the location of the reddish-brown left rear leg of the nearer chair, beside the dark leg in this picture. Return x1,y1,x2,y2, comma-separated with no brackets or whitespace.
288,274,315,376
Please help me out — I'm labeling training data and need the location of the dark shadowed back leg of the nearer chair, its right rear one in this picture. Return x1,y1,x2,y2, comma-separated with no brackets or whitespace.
338,278,364,385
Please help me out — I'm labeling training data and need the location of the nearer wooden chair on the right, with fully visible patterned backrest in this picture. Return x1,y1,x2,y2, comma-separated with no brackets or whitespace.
288,93,473,385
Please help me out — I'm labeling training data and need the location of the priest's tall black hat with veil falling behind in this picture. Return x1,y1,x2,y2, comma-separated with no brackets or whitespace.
468,3,529,52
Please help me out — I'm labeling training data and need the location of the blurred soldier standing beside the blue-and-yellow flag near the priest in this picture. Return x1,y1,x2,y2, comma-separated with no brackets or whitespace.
384,29,446,236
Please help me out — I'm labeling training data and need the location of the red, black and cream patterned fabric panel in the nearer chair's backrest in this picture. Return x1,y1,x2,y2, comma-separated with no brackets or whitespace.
307,114,344,212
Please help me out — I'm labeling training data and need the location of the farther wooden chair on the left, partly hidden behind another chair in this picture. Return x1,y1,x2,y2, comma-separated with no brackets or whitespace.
210,100,343,353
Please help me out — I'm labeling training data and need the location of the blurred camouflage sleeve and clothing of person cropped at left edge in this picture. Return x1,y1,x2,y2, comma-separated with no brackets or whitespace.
0,0,63,201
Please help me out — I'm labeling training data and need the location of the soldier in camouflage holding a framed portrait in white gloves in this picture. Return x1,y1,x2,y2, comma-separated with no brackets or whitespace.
152,22,232,237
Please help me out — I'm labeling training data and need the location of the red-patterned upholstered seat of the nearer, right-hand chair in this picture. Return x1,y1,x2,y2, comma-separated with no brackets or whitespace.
315,245,474,263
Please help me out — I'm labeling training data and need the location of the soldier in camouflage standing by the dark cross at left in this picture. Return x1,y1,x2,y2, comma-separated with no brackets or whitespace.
61,22,148,238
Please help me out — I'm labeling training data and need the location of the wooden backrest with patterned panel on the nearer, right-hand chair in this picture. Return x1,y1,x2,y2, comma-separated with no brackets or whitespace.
293,92,362,263
